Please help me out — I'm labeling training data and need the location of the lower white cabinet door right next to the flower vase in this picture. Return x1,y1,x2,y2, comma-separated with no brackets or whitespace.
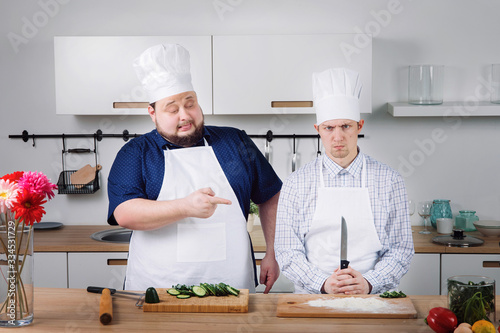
33,252,68,288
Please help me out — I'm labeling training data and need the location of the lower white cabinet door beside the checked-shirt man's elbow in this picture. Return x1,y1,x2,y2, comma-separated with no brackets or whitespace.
398,253,440,295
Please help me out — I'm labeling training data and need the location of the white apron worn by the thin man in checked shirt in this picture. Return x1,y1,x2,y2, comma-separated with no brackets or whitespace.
295,156,382,293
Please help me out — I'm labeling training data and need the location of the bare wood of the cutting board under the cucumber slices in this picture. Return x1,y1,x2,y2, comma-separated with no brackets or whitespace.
142,288,249,312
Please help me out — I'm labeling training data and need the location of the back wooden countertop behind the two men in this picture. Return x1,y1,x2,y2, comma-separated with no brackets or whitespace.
34,225,500,254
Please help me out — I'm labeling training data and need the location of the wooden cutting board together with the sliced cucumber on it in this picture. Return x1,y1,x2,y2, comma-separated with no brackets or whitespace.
142,284,249,313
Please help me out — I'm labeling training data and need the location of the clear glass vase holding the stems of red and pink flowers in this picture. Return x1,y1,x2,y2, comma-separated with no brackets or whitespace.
0,221,33,327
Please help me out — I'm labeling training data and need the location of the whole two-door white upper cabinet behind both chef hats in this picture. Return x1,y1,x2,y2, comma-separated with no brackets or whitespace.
54,34,372,115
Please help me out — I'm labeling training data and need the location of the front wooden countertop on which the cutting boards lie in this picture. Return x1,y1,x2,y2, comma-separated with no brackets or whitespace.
6,288,476,333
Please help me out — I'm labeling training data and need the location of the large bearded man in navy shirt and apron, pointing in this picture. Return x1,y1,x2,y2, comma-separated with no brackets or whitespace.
108,44,281,293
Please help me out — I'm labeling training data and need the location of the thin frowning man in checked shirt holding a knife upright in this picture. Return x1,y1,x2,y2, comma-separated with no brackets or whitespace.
275,68,414,294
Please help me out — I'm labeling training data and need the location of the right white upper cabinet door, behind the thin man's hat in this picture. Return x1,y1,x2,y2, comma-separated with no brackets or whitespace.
213,34,372,115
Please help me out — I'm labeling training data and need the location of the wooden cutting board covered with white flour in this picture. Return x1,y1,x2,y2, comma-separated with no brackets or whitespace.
277,294,417,318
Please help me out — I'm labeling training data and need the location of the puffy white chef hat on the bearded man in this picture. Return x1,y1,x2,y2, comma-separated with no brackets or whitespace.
133,44,194,103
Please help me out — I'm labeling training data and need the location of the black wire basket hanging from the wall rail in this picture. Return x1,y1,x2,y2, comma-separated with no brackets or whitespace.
57,134,101,194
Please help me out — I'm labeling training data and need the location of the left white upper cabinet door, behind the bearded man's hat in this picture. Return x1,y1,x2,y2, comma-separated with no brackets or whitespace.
54,36,212,115
